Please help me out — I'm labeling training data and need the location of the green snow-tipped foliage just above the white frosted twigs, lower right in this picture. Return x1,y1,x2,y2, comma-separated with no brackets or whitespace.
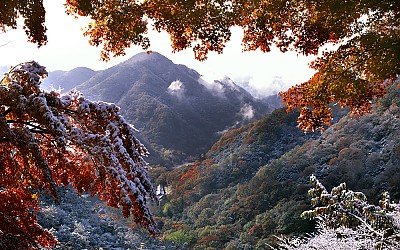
301,175,398,232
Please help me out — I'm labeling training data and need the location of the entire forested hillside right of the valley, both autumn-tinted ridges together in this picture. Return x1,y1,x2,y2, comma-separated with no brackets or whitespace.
154,82,400,249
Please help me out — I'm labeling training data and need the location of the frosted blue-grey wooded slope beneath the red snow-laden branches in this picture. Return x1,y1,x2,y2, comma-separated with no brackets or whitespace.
38,188,182,250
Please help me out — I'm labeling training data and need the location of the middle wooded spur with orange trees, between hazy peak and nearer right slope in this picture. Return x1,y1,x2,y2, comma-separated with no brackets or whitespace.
151,109,316,249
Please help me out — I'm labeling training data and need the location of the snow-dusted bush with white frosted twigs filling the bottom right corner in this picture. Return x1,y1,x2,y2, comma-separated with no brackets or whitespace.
279,176,400,250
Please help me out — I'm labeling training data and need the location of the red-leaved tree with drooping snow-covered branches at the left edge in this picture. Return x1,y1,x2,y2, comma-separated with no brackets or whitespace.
0,62,156,249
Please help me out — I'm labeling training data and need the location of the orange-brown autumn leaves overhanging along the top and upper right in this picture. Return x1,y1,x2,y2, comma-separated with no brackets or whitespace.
0,0,400,131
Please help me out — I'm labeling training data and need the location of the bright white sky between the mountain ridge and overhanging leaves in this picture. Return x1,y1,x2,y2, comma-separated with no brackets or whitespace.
0,0,313,95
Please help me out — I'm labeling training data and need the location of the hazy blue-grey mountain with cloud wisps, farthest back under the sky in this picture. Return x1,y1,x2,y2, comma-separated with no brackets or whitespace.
39,52,280,164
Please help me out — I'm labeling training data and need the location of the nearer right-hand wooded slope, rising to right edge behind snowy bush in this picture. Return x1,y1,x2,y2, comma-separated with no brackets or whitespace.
219,84,400,246
